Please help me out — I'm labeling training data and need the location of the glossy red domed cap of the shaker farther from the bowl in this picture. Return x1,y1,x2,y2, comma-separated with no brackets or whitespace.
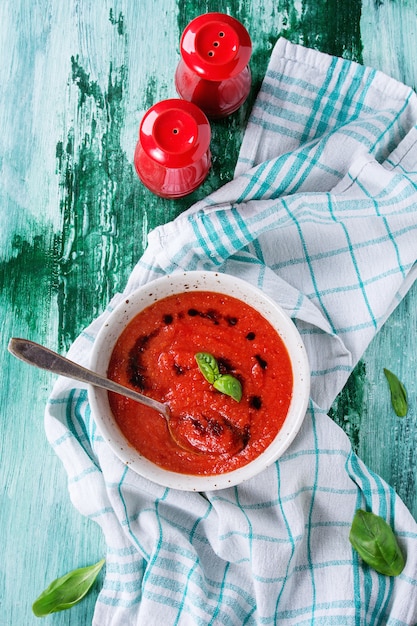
176,13,252,81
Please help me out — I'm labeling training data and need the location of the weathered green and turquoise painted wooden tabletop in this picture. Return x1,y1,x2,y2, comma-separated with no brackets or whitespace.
0,0,417,626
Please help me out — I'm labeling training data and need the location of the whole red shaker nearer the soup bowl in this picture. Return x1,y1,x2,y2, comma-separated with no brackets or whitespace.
134,98,211,198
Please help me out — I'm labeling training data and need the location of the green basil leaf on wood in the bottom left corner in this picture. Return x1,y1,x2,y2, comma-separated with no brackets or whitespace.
32,559,105,617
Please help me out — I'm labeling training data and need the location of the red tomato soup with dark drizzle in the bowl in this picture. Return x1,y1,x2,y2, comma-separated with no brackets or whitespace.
108,291,293,475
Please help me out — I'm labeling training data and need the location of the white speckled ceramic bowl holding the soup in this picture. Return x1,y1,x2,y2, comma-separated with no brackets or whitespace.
89,271,310,491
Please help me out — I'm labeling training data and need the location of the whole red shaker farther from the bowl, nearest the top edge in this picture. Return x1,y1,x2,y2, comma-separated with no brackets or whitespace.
175,13,252,119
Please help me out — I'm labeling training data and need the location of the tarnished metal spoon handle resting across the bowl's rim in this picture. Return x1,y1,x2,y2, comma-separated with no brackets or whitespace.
8,337,168,418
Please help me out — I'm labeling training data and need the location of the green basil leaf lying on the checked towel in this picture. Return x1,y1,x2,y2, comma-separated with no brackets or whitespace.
349,509,405,576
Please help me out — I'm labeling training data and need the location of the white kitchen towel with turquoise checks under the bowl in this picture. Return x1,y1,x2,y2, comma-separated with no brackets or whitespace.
46,39,417,626
